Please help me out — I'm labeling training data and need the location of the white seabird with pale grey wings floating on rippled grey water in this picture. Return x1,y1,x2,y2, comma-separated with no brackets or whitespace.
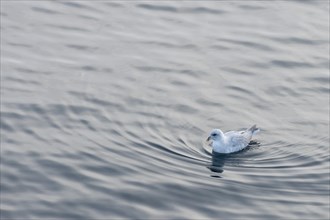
207,125,260,154
